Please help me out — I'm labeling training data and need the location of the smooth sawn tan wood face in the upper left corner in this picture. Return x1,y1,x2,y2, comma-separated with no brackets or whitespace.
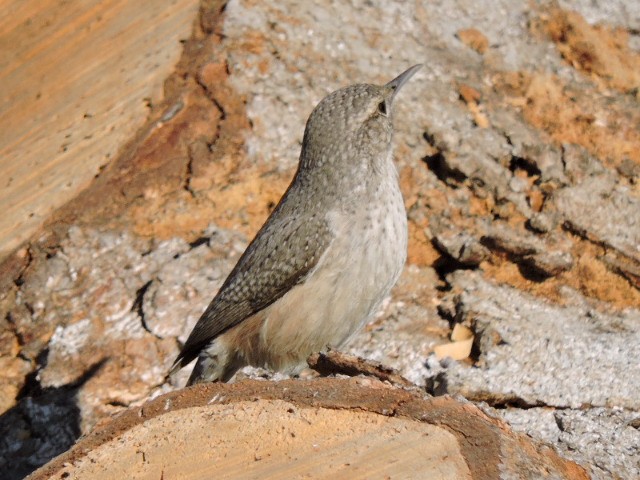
0,0,198,259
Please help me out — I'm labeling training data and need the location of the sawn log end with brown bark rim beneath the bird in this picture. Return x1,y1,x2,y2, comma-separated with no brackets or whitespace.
30,378,588,480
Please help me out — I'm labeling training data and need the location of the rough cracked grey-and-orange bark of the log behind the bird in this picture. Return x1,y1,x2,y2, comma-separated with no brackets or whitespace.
0,0,640,479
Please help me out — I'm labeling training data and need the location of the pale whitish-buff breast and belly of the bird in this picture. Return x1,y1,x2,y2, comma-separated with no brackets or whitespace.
255,188,407,369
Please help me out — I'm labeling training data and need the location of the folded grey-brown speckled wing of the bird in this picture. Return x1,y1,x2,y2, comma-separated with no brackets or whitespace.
172,201,333,371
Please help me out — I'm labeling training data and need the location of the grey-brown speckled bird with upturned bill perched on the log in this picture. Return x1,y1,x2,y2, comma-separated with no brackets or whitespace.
172,65,421,385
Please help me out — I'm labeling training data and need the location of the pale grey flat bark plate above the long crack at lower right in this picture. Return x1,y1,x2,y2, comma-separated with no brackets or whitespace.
440,272,640,410
